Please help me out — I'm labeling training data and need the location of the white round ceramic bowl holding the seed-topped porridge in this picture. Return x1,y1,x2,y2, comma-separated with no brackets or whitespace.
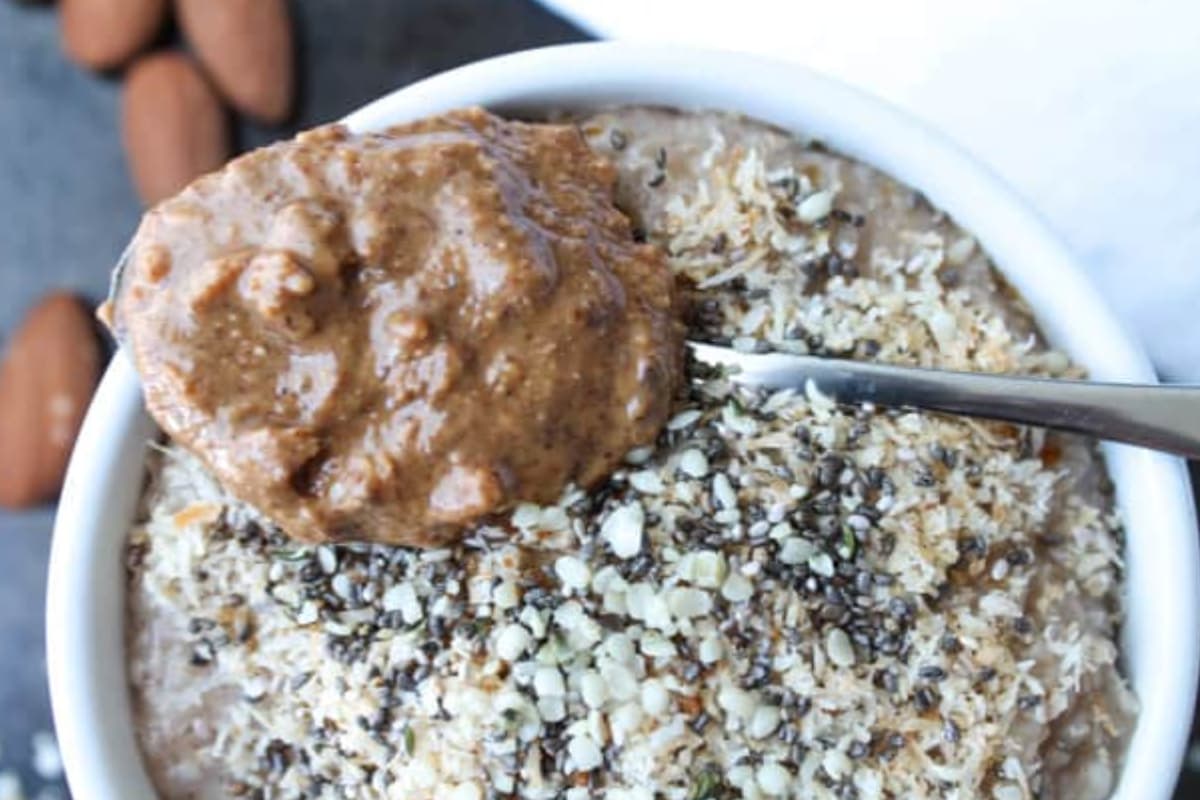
47,43,1200,800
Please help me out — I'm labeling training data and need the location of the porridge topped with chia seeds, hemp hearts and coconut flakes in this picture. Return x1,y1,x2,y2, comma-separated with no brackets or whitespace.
127,108,1136,800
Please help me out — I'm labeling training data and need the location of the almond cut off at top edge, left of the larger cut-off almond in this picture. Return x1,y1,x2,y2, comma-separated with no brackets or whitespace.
59,0,167,70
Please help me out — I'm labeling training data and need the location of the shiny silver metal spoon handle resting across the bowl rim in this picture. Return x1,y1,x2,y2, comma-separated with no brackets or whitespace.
688,342,1200,458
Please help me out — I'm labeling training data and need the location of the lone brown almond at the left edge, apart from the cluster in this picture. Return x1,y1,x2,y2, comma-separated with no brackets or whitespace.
0,291,102,509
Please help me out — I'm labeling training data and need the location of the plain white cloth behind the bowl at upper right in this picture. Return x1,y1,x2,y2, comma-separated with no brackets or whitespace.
544,0,1200,381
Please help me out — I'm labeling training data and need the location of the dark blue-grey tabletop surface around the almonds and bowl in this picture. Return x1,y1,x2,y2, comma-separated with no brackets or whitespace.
0,0,1200,800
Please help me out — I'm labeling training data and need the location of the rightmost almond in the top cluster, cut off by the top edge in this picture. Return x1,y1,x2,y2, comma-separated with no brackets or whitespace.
175,0,295,122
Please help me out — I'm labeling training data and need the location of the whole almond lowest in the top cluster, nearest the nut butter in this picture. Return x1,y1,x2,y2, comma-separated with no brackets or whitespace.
121,53,229,205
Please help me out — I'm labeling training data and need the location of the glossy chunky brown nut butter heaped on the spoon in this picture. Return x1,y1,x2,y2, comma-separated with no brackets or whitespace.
115,109,682,546
